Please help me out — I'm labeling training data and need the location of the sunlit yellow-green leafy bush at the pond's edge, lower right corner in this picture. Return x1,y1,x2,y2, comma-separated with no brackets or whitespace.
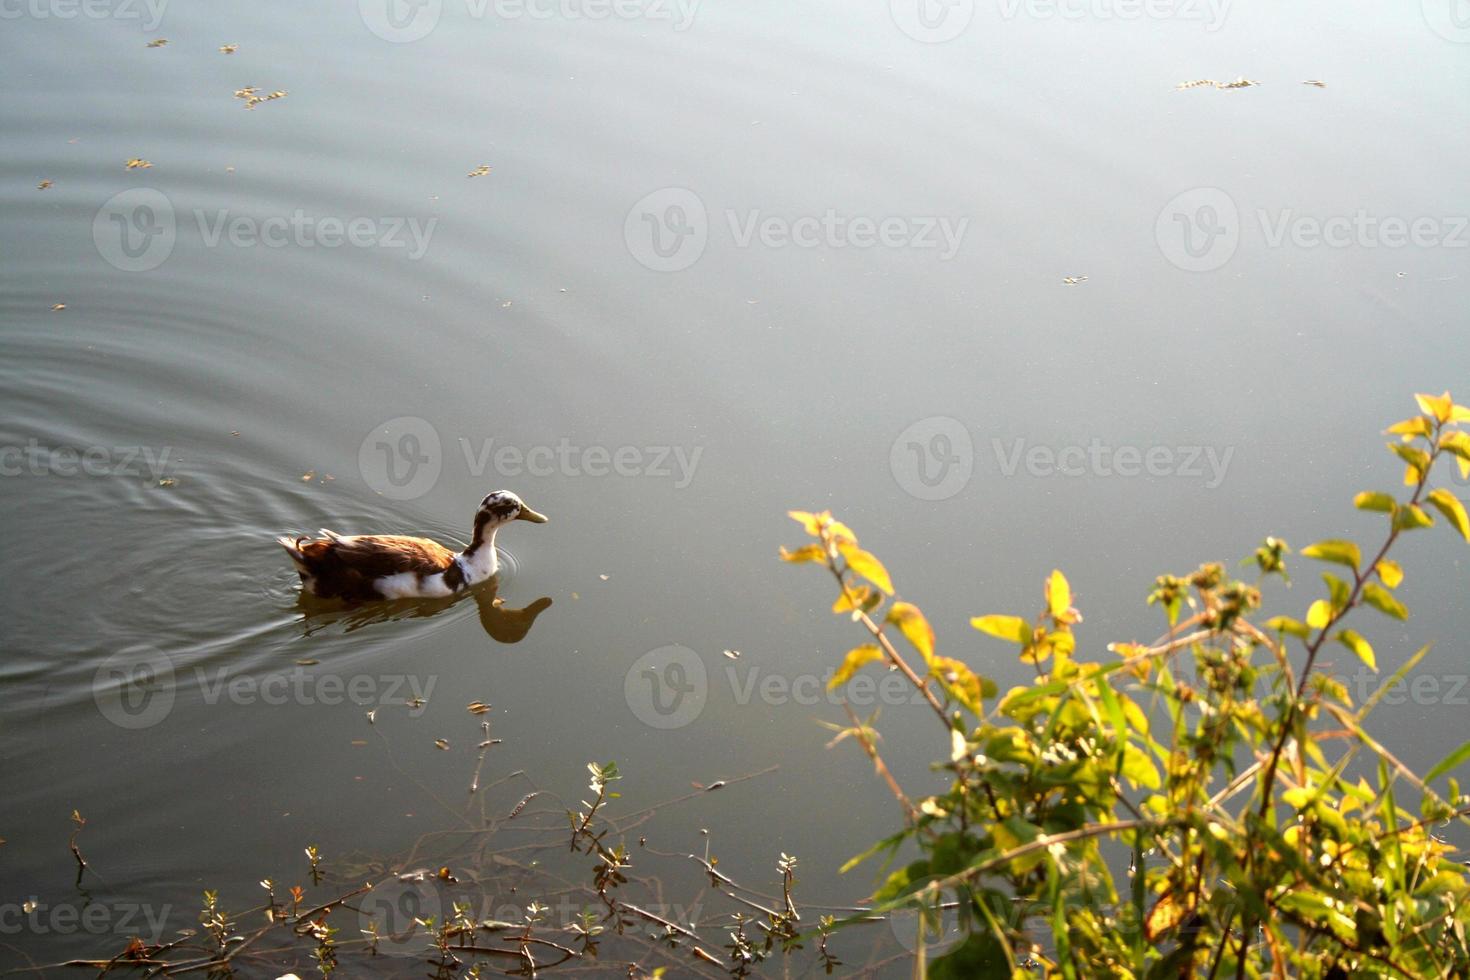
782,392,1470,979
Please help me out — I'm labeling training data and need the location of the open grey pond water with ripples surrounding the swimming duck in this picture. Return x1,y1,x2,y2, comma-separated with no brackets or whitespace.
0,0,1470,976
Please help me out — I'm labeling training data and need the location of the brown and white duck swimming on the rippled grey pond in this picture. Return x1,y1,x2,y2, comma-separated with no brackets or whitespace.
276,491,548,602
